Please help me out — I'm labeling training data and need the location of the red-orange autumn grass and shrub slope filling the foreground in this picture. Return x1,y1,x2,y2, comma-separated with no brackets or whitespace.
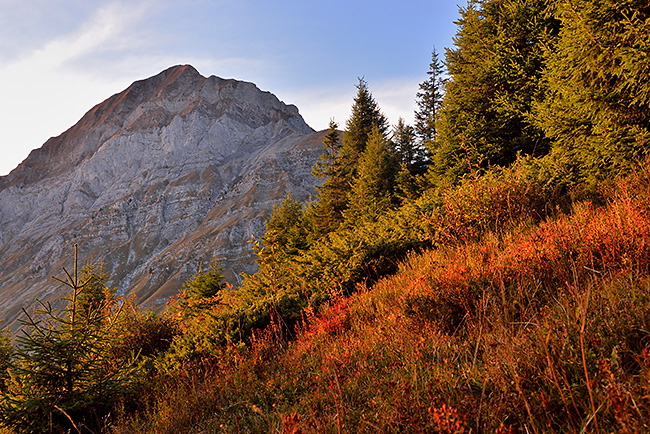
113,164,650,433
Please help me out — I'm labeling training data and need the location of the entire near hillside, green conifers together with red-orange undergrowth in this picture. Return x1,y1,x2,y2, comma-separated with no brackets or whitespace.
0,0,650,434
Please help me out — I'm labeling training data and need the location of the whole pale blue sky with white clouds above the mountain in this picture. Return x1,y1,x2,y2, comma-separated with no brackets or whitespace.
0,0,466,175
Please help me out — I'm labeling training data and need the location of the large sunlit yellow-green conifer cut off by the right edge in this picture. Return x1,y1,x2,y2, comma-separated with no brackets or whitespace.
537,0,650,179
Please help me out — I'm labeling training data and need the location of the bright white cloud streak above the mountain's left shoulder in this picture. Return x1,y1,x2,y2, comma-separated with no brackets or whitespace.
0,3,144,175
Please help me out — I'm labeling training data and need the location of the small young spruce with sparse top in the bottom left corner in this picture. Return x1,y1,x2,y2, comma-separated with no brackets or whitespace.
0,246,136,433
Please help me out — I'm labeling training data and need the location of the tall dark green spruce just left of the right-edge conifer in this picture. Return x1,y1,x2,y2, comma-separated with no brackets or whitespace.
432,0,558,181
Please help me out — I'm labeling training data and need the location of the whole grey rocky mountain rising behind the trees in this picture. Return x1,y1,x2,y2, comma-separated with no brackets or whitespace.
0,66,322,324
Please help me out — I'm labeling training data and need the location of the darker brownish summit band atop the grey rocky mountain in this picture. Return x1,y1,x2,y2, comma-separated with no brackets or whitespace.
0,65,313,189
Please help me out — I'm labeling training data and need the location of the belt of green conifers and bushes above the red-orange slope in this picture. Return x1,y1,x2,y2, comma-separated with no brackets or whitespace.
0,0,650,432
